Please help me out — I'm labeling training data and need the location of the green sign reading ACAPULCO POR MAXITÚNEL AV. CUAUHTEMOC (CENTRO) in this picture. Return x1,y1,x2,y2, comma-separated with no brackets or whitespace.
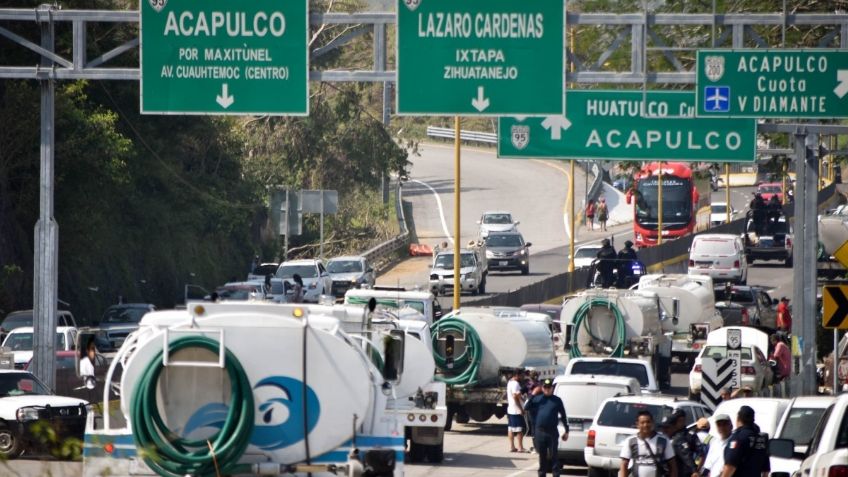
140,0,309,115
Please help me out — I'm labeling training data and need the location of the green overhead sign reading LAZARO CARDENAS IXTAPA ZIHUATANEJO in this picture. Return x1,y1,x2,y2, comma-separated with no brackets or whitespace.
397,0,565,116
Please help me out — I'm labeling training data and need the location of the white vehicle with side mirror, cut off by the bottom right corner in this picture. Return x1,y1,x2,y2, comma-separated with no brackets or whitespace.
769,394,848,477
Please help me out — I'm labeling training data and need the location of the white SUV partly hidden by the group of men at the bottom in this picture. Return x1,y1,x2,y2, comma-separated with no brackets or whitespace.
584,395,710,477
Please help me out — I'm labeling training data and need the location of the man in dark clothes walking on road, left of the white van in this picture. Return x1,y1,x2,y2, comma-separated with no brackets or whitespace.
527,379,568,477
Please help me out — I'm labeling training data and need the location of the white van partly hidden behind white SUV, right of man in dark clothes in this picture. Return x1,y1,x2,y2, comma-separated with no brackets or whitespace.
554,374,642,465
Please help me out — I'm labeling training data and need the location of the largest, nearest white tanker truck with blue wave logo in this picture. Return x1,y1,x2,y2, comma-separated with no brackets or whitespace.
83,302,413,477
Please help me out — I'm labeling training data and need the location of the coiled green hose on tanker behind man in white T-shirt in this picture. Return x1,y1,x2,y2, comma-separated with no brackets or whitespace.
430,318,483,386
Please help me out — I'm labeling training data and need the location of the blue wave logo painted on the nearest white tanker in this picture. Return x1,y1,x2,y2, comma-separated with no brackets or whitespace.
183,376,321,450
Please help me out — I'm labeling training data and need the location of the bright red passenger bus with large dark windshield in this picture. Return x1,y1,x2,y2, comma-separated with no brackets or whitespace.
626,162,710,247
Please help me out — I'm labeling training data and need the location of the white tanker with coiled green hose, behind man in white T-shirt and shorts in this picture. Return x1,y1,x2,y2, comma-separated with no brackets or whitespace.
432,307,557,430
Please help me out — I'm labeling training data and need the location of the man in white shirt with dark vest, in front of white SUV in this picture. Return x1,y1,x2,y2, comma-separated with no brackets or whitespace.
618,410,677,477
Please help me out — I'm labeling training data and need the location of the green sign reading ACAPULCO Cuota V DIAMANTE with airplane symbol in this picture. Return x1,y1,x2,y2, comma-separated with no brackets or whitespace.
696,50,848,118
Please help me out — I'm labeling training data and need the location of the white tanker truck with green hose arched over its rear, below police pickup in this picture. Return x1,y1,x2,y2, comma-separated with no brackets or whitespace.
560,288,671,388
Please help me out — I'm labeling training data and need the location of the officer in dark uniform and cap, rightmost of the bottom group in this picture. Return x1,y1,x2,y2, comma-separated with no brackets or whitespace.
721,406,771,477
